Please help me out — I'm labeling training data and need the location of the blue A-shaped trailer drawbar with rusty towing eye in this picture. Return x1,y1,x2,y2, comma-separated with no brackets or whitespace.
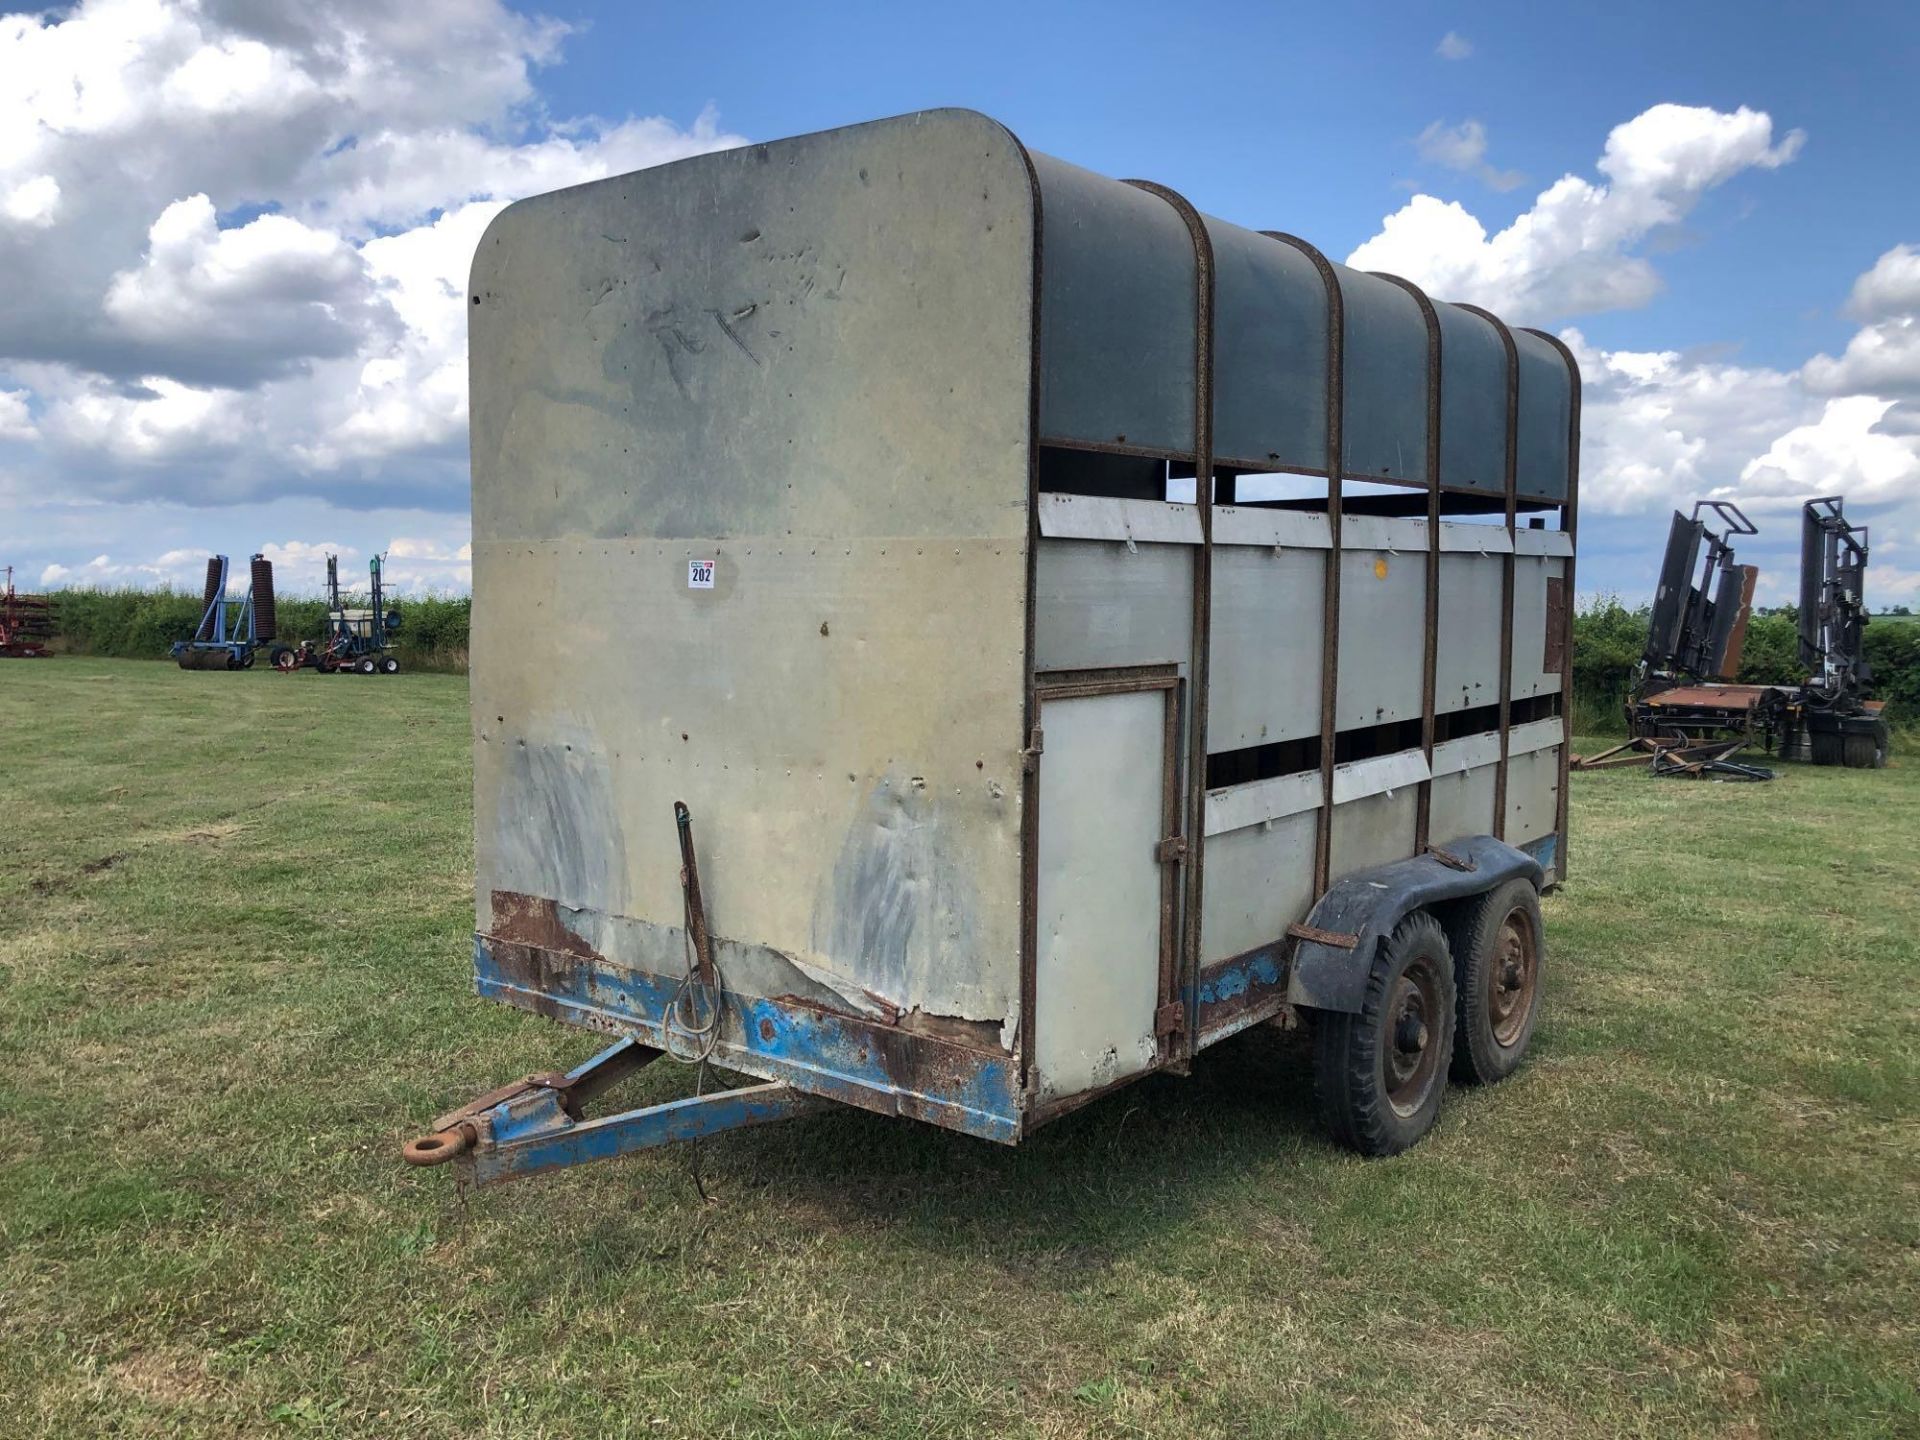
401,1039,824,1185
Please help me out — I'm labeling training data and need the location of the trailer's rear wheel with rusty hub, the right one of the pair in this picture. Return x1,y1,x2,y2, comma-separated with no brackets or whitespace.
1448,879,1546,1085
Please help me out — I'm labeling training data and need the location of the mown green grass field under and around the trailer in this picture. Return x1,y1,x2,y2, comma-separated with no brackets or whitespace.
0,659,1920,1440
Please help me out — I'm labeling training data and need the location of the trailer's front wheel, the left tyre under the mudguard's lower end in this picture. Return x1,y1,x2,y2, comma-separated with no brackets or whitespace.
1313,910,1453,1156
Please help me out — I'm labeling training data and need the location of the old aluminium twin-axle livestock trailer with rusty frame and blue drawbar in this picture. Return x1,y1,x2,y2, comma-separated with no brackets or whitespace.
407,111,1580,1181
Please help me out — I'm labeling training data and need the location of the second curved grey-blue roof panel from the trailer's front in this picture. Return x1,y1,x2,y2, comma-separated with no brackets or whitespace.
1204,215,1327,470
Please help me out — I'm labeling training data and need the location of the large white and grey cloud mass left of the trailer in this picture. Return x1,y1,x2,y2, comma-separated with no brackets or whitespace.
0,0,739,507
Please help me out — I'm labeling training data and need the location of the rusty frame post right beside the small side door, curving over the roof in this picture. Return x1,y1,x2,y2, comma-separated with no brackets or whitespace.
1127,180,1213,1069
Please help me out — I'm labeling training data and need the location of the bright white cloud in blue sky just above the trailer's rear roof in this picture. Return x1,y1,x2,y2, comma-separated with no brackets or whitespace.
1348,106,1805,324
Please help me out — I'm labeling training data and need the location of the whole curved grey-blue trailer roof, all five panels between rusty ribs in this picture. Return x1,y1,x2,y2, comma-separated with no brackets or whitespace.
1031,138,1578,503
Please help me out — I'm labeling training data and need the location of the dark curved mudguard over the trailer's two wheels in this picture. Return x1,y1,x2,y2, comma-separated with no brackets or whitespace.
1286,835,1546,1014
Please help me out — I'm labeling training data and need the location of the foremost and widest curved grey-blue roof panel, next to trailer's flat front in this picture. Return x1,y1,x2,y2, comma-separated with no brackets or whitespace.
1033,154,1196,455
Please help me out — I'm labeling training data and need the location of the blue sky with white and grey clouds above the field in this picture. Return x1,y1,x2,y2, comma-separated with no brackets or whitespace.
0,0,1920,609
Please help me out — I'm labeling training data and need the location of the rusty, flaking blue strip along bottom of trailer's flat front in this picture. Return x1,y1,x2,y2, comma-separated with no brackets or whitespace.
474,935,1023,1144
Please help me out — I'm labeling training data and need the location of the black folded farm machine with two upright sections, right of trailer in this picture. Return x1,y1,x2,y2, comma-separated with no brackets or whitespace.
1576,495,1887,778
